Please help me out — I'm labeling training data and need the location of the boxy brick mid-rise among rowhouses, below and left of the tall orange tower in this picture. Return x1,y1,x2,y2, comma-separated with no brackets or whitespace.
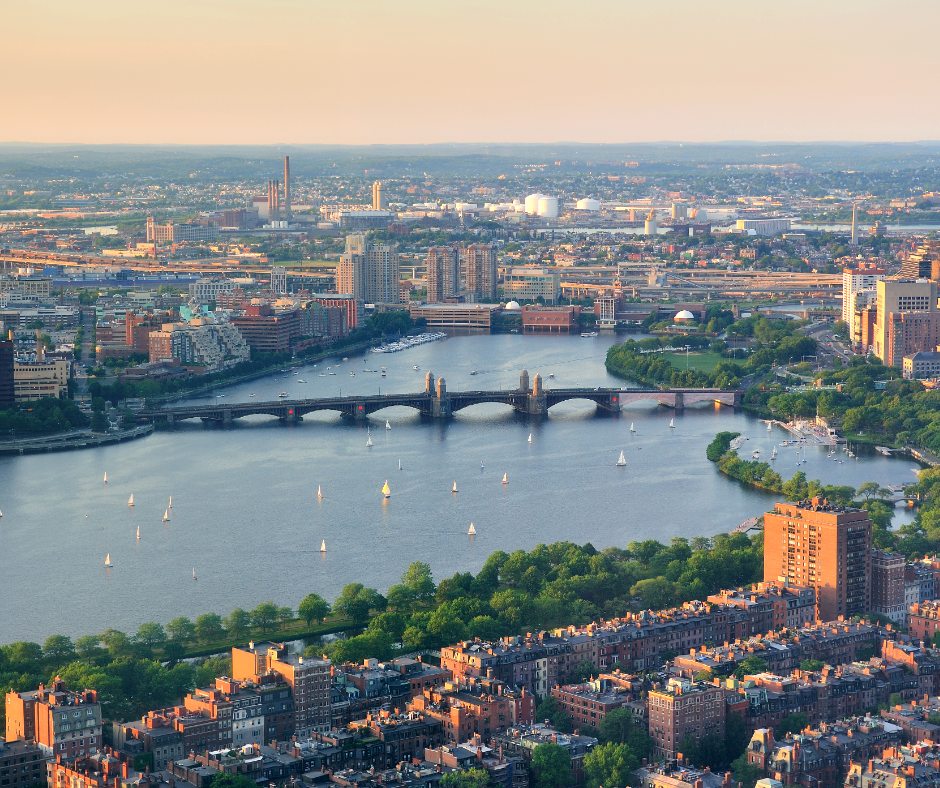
647,678,726,759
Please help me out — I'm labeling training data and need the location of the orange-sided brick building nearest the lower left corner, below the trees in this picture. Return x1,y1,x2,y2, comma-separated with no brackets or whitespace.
6,678,103,758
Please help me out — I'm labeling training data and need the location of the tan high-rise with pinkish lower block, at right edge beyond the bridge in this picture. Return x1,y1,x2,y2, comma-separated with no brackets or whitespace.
873,279,940,367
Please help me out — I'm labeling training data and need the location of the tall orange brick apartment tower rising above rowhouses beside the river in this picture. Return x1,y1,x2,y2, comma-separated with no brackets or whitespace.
764,498,871,621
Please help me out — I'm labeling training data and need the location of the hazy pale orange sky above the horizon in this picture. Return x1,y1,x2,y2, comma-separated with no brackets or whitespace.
0,0,940,143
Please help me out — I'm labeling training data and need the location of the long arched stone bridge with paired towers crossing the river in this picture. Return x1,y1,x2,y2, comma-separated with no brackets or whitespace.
138,370,742,424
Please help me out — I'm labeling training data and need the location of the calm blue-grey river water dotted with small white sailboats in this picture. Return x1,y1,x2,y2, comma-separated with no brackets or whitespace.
0,335,913,643
